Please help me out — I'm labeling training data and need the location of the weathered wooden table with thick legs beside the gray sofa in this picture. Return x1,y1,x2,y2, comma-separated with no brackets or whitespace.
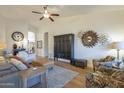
20,67,47,88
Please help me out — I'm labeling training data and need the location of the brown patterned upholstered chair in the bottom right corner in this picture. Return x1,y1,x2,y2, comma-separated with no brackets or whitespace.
86,66,124,88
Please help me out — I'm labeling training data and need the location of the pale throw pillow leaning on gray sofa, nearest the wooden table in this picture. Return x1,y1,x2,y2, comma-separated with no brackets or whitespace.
10,58,28,70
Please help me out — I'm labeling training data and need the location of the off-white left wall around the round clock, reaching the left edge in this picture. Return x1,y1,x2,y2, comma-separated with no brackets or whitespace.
0,15,38,51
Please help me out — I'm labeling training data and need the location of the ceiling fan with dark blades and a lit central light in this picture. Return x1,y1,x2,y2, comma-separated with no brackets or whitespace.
32,5,60,22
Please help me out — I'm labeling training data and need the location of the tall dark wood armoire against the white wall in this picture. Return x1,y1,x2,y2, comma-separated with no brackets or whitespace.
54,34,74,62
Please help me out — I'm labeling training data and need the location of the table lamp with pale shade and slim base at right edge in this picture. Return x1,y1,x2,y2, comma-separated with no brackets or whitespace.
110,42,124,60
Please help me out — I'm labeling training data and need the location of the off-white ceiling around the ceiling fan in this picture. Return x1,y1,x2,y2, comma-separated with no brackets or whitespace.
0,5,124,20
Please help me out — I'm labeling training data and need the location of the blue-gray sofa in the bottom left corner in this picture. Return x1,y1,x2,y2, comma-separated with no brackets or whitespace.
0,63,21,88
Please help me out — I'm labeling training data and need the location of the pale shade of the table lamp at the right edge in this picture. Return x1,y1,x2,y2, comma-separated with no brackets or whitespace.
110,42,124,50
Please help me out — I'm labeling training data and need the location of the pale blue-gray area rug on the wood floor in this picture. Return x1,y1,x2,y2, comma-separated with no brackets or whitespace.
47,66,79,88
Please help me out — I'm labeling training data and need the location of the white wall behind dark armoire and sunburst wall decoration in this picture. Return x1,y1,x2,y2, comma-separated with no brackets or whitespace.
38,11,124,66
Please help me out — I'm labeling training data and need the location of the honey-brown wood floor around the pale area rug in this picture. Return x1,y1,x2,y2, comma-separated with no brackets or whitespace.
55,62,93,88
